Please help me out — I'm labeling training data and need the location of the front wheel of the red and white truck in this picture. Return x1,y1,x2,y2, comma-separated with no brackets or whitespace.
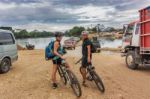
126,51,138,70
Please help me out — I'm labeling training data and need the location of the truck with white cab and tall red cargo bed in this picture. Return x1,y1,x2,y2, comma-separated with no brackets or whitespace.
122,6,150,69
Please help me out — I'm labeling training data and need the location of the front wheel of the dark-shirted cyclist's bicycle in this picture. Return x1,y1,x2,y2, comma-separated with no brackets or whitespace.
91,72,105,93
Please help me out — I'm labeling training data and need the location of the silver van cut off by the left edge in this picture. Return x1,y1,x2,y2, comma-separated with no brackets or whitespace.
0,29,18,73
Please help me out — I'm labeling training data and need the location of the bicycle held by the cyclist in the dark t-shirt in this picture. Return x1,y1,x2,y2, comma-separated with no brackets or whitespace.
75,58,105,93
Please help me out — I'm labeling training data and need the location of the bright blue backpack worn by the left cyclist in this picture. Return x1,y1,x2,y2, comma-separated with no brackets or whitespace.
45,41,54,60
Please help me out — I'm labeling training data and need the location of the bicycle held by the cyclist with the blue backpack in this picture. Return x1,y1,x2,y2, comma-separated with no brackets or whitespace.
58,60,82,97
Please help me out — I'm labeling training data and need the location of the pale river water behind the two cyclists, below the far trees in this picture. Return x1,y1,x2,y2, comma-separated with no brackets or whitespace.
17,37,122,49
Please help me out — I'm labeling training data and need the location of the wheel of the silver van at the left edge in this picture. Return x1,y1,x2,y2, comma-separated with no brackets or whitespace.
0,58,11,73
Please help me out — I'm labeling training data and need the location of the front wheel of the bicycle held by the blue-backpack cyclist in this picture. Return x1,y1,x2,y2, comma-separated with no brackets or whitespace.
67,70,82,97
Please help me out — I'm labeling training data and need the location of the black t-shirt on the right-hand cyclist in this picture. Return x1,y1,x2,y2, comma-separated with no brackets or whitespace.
82,39,92,57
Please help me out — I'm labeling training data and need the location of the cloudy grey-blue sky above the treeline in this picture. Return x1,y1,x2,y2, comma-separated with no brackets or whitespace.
0,0,150,31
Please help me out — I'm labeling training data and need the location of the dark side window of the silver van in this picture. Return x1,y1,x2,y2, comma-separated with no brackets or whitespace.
0,32,15,45
